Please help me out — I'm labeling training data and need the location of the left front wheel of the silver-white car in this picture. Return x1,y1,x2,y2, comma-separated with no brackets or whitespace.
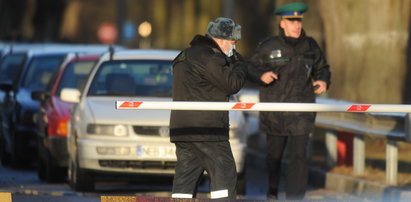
68,160,94,191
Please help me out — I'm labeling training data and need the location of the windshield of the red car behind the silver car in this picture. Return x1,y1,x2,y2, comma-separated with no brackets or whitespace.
56,61,95,96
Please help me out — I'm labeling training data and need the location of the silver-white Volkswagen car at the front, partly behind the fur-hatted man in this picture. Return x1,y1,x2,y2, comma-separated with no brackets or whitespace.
61,50,247,193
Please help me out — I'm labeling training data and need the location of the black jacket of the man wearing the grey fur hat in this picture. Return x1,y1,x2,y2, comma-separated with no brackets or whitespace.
170,35,247,142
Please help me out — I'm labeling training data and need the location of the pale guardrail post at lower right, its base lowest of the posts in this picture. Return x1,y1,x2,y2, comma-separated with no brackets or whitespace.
385,139,398,185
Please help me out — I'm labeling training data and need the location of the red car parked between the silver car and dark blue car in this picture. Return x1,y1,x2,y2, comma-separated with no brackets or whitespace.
32,53,100,182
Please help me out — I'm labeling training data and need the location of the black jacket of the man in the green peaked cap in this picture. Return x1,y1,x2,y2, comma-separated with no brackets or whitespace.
249,29,331,136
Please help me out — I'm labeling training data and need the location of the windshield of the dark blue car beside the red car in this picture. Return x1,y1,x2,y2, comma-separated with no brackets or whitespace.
22,56,64,90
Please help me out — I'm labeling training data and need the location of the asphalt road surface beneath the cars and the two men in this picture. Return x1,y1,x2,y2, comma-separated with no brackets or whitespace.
0,151,367,202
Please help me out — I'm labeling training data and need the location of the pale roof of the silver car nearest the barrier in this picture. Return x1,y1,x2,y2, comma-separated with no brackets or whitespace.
102,49,180,60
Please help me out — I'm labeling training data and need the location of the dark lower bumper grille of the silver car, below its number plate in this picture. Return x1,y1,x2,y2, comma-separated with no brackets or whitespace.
99,160,177,170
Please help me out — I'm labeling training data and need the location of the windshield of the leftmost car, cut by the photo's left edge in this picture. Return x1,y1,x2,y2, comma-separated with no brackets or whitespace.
0,54,25,82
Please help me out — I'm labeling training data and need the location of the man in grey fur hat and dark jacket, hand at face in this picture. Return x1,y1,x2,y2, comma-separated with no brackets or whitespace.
170,18,247,198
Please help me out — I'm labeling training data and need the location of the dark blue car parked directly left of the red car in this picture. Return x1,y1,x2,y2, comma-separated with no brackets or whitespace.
0,45,112,166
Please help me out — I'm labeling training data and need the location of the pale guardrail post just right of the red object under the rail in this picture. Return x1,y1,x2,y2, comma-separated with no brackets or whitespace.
353,134,365,175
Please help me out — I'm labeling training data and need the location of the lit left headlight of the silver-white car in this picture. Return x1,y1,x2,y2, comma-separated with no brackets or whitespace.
87,124,128,137
